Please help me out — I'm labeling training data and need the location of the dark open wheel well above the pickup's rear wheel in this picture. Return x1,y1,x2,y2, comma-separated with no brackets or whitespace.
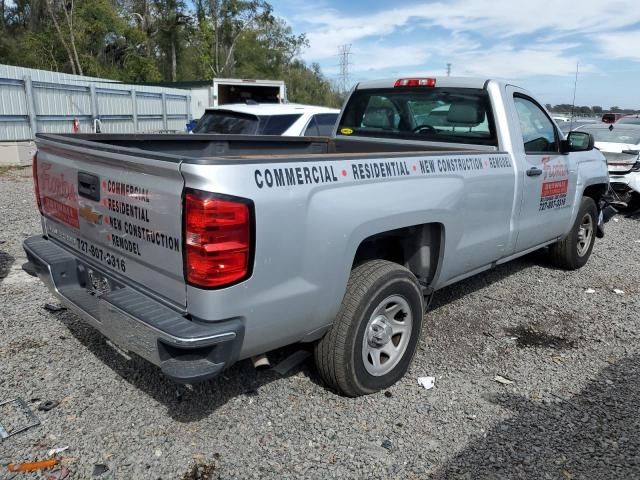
353,223,443,285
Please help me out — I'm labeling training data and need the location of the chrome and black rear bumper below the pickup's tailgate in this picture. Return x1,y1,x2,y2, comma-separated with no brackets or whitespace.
23,236,244,383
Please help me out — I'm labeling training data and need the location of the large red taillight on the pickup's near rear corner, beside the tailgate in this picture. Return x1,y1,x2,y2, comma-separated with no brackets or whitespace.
184,193,251,288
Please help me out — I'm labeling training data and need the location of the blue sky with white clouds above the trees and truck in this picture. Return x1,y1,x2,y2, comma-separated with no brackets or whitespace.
270,0,640,109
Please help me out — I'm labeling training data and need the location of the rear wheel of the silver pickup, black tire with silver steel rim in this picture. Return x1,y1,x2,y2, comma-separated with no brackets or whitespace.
315,260,424,397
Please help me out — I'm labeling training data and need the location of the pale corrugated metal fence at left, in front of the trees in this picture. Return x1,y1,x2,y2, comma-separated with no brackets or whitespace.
0,65,191,141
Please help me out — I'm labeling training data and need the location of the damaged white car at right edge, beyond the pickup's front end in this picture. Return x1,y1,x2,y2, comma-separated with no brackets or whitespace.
579,123,640,208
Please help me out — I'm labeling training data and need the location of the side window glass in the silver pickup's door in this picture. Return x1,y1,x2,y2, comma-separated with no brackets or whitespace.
513,96,558,154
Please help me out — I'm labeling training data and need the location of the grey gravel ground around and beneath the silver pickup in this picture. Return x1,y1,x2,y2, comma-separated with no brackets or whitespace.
0,166,640,480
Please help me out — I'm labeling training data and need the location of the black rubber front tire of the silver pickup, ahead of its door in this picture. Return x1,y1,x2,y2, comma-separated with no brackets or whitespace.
550,197,598,270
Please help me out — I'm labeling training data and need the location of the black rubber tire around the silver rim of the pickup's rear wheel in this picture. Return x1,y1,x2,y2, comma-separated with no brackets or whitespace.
314,260,424,397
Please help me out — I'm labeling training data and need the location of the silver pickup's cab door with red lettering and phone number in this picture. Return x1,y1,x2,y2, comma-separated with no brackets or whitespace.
507,87,577,252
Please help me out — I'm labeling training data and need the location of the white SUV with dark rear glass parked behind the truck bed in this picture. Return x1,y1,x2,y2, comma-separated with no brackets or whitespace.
193,102,340,137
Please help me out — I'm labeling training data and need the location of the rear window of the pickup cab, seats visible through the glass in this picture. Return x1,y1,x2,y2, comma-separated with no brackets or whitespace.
338,88,497,145
